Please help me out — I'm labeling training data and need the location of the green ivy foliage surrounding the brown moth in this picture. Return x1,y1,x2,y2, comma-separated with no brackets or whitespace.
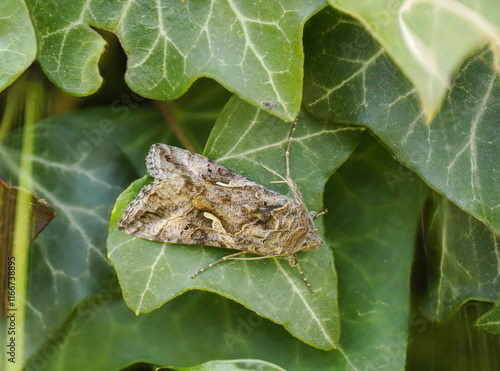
0,0,500,370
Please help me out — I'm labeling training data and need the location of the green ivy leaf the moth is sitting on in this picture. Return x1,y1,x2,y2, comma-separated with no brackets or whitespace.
108,99,361,349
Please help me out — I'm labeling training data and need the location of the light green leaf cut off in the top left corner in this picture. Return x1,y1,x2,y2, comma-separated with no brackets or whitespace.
0,0,36,91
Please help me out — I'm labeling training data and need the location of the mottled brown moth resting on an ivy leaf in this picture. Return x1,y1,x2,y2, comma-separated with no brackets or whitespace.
118,121,326,293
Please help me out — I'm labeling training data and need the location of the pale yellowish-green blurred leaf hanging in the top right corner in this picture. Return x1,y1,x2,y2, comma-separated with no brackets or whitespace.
329,0,500,117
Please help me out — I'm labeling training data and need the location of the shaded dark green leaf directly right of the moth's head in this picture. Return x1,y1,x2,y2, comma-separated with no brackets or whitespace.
325,132,428,370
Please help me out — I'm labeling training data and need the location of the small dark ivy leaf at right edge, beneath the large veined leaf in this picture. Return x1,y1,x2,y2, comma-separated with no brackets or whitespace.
425,195,500,321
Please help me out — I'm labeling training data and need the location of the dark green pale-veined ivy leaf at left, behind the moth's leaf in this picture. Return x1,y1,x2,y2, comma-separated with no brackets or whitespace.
0,106,176,356
